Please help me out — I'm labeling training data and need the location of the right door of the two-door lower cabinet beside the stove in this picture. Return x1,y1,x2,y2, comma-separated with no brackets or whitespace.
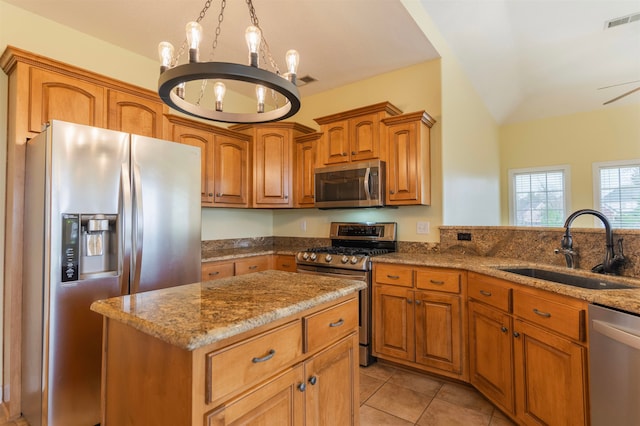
414,292,463,374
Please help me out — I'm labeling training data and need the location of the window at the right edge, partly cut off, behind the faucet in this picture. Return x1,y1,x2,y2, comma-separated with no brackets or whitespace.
593,159,640,228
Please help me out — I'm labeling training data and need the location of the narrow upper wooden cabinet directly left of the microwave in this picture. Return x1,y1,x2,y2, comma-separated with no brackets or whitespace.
293,133,322,208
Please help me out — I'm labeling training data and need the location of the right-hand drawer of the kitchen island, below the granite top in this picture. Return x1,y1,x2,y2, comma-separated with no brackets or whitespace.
303,299,359,352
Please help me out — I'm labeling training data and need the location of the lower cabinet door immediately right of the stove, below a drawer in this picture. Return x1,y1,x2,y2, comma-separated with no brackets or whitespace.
373,285,415,361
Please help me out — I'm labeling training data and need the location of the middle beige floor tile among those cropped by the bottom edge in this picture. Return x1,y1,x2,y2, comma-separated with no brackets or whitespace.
417,398,491,426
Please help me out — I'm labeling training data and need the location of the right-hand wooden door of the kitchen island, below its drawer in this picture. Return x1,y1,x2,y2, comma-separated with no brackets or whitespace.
305,333,360,426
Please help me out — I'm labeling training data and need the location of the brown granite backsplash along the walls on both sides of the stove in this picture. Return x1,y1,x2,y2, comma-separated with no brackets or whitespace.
202,226,640,278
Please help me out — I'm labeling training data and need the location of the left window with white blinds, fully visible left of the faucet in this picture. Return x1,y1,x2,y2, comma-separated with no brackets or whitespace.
509,166,571,227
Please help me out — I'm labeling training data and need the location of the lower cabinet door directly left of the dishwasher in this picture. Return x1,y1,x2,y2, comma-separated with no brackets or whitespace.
514,320,588,425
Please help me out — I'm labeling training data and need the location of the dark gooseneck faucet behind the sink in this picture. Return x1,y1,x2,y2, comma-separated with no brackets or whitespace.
555,209,626,275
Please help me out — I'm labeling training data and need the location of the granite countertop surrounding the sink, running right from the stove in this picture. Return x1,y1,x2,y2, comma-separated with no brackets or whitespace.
371,253,640,315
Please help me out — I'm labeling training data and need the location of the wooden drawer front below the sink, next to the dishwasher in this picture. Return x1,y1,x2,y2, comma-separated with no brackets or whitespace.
513,290,586,341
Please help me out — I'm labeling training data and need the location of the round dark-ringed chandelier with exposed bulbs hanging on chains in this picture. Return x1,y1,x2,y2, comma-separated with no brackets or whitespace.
158,0,300,123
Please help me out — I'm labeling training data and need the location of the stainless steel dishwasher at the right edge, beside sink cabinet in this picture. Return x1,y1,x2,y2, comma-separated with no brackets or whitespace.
589,305,640,426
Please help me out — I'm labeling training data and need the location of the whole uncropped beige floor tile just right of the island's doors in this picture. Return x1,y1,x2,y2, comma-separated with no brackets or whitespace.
365,383,432,423
